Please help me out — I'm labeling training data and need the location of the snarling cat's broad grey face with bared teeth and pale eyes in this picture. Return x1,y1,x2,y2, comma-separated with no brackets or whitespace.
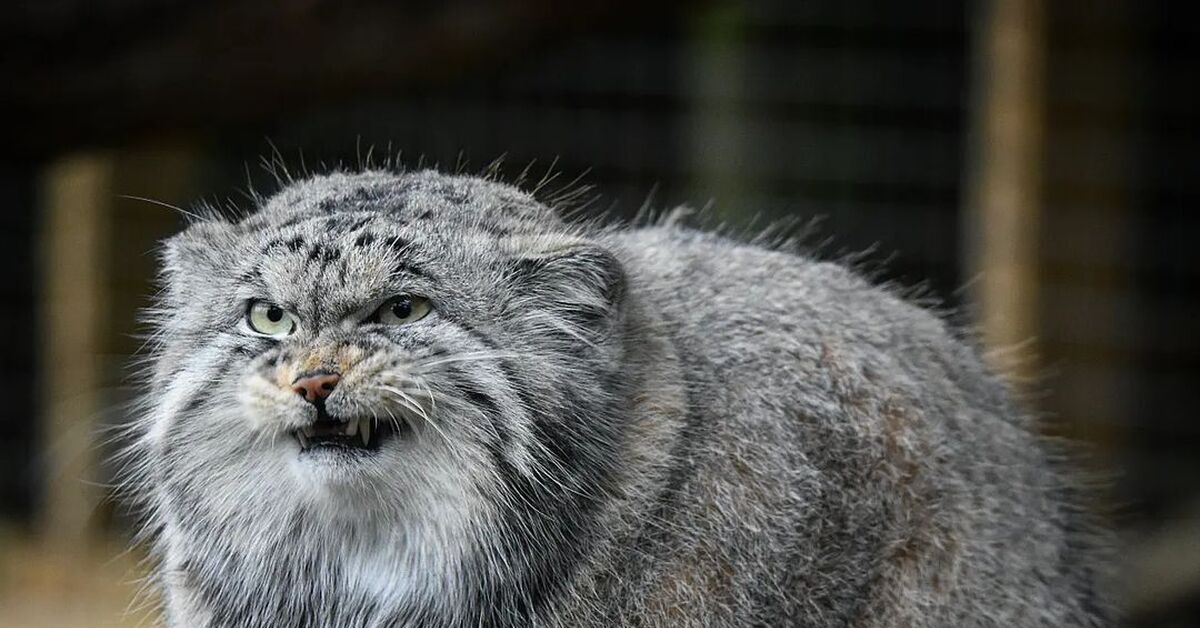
144,173,623,564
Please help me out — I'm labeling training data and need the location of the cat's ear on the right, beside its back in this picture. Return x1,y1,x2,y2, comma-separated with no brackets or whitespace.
510,237,625,333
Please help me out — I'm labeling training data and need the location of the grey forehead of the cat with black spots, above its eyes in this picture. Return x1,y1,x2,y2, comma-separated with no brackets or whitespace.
220,172,559,324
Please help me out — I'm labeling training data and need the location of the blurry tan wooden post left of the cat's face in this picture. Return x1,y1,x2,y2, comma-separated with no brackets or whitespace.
40,155,114,551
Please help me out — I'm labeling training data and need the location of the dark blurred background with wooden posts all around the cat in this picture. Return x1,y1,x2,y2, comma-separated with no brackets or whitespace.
0,0,1200,627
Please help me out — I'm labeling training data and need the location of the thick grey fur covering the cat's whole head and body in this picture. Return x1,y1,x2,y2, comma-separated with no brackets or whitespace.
132,171,1110,628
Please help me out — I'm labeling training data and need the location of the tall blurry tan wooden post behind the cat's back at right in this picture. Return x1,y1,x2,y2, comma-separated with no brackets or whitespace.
964,0,1044,381
